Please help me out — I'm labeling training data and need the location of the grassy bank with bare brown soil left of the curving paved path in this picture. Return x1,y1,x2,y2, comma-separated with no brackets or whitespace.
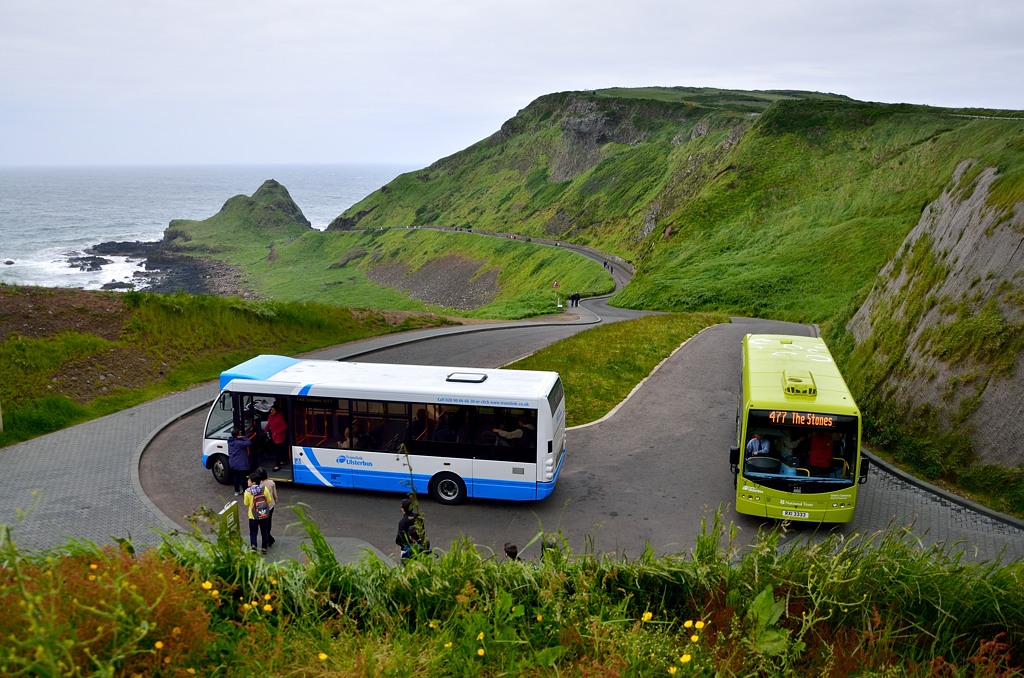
0,290,446,446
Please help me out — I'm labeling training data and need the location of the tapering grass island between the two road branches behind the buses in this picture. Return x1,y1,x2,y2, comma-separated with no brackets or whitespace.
506,313,729,426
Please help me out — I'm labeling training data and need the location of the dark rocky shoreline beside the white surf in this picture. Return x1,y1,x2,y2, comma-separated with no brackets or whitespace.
82,241,258,299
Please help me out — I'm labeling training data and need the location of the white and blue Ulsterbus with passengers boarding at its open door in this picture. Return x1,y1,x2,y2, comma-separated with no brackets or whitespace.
203,355,565,504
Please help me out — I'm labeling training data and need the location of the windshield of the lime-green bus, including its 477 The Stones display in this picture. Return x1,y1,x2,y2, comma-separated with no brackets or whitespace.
742,410,858,494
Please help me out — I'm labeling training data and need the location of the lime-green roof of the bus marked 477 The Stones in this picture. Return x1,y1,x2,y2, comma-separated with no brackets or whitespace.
743,334,860,416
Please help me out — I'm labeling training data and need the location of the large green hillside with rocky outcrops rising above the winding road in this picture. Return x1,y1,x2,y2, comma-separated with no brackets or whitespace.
329,88,1024,506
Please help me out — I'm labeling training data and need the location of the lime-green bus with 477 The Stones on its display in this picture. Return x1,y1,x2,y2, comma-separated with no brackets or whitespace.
729,334,867,522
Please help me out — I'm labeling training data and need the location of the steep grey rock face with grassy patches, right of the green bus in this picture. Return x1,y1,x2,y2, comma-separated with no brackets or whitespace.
847,161,1024,466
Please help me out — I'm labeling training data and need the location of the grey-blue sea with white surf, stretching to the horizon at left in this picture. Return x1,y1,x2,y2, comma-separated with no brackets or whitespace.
0,165,417,290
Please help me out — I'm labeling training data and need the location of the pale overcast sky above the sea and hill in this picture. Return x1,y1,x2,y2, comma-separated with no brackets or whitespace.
0,0,1024,165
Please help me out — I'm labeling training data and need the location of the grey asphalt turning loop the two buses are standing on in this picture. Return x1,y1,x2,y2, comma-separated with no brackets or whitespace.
139,315,1024,559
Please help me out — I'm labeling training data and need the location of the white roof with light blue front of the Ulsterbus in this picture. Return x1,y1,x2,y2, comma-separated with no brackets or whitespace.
220,355,559,399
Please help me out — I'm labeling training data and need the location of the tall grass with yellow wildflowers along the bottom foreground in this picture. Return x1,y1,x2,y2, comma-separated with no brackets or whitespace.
0,506,1024,676
